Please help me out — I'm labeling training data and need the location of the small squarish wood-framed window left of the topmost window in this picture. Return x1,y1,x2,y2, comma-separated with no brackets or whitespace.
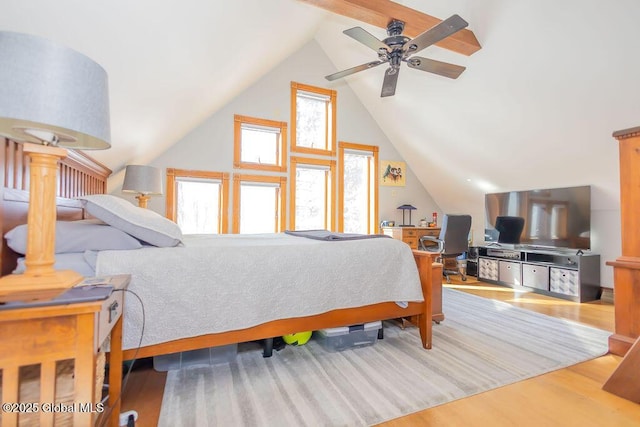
233,115,287,172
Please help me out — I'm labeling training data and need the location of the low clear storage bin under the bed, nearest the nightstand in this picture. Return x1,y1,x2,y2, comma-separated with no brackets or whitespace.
153,344,238,372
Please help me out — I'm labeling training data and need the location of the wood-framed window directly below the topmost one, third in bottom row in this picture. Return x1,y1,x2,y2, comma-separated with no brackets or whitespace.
289,157,336,230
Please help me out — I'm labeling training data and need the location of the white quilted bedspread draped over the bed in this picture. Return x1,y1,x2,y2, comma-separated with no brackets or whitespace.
96,233,423,349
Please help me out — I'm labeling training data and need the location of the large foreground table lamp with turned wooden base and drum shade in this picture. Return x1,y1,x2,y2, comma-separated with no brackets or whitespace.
0,31,111,301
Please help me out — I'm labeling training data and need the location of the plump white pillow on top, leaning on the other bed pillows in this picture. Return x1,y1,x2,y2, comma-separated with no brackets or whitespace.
78,194,182,247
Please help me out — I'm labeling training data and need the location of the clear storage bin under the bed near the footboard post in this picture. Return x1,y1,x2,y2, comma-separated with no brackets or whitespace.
314,320,382,352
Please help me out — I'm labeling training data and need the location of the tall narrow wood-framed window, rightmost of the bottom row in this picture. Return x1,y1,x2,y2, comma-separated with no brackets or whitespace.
338,142,378,234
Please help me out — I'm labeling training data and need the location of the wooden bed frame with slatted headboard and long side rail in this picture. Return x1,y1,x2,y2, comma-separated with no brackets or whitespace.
0,139,434,354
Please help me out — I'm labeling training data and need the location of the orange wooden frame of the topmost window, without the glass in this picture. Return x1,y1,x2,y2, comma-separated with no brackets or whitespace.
290,82,337,157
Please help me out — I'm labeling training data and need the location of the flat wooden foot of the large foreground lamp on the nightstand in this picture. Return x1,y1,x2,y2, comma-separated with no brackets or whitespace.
0,270,84,302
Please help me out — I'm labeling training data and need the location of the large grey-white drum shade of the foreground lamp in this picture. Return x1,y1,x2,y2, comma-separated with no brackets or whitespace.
0,31,111,149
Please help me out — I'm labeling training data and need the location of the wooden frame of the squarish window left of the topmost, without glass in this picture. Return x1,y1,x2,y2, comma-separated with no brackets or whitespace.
233,114,287,172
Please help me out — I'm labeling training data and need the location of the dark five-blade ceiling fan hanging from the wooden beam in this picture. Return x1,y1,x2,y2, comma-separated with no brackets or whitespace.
325,15,469,97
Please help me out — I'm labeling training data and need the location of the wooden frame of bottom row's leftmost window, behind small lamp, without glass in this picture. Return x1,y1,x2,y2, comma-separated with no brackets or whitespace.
165,168,229,234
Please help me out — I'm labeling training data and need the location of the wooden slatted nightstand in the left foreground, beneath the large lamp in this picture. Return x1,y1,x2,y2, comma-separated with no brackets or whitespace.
0,275,130,426
